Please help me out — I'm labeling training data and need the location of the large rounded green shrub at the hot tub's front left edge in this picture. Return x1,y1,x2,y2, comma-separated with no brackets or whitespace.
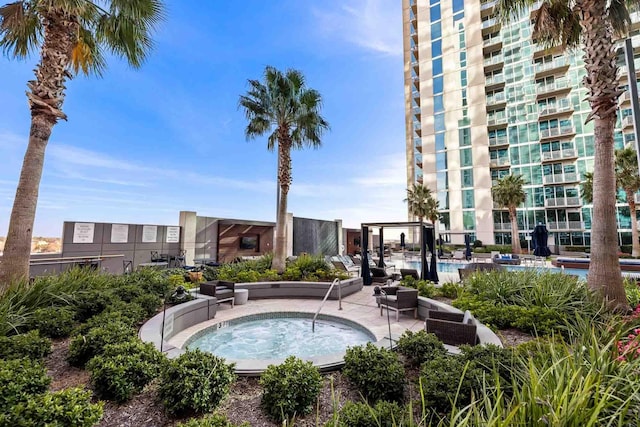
159,350,235,415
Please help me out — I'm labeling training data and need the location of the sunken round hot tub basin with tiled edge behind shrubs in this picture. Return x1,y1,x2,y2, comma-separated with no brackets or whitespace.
183,312,376,375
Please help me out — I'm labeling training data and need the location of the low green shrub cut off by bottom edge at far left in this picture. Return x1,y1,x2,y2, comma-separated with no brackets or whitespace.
5,388,103,427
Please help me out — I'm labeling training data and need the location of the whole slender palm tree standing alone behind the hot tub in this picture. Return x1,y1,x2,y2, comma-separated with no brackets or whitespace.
239,66,329,273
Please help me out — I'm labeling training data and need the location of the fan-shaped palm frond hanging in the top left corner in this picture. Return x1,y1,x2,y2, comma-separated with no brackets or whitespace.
0,1,42,59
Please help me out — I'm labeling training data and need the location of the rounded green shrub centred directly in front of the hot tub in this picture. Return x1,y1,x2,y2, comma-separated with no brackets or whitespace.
260,356,322,421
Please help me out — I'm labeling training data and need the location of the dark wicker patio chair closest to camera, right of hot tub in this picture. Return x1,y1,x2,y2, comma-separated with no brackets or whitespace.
425,310,478,345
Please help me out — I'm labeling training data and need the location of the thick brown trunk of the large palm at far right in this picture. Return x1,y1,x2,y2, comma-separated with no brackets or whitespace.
576,0,629,310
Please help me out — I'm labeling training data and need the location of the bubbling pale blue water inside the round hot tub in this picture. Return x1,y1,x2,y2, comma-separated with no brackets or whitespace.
187,317,374,360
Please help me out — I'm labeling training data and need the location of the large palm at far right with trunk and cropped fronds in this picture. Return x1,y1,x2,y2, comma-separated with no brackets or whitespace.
496,0,638,310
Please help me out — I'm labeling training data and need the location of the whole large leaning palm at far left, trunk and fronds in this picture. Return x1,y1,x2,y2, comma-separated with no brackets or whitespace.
0,0,163,290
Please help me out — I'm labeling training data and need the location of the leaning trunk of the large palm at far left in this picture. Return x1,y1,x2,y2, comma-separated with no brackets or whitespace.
0,10,78,292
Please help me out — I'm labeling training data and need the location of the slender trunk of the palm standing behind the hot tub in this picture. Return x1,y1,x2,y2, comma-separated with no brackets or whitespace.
272,135,291,274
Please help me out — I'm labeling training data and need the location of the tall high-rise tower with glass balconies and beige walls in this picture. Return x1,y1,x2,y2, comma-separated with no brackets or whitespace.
402,0,640,251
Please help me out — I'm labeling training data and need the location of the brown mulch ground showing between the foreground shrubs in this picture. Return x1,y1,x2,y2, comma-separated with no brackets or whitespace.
45,329,533,427
